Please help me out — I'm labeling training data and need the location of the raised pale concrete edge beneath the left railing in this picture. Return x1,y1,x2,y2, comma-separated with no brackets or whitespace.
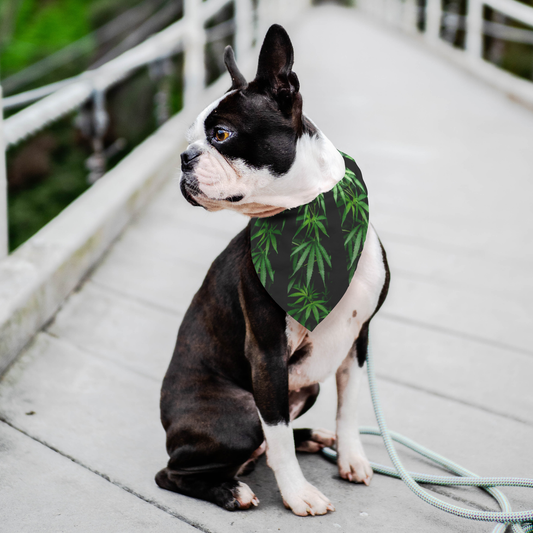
0,74,231,375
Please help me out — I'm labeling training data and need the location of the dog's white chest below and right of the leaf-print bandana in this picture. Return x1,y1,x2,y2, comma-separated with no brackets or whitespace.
286,222,385,390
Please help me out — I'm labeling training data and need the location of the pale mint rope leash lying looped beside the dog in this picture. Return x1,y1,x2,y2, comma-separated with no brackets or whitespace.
322,334,533,533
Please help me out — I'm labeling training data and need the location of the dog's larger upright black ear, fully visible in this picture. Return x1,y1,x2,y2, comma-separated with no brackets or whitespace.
255,24,300,113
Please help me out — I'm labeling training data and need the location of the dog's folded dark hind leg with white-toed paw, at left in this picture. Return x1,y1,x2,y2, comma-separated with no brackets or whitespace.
155,380,264,511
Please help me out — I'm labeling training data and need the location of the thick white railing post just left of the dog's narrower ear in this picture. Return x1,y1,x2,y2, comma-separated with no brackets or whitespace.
183,0,205,107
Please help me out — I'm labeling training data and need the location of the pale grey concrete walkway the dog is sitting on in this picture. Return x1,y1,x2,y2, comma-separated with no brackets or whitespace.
0,6,533,533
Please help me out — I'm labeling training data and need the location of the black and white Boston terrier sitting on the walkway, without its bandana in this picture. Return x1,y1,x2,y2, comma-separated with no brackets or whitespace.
156,25,389,516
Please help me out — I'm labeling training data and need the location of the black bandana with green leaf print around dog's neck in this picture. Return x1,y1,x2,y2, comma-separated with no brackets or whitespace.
250,152,369,331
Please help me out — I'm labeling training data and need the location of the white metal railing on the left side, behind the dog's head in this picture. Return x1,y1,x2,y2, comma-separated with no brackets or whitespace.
0,0,311,259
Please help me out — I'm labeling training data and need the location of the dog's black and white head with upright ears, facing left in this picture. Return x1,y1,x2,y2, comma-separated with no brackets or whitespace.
180,25,344,216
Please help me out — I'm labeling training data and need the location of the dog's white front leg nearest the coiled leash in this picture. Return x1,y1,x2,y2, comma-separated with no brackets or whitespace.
336,325,373,485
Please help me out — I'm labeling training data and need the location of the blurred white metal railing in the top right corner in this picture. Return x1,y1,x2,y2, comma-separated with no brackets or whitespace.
356,0,533,107
